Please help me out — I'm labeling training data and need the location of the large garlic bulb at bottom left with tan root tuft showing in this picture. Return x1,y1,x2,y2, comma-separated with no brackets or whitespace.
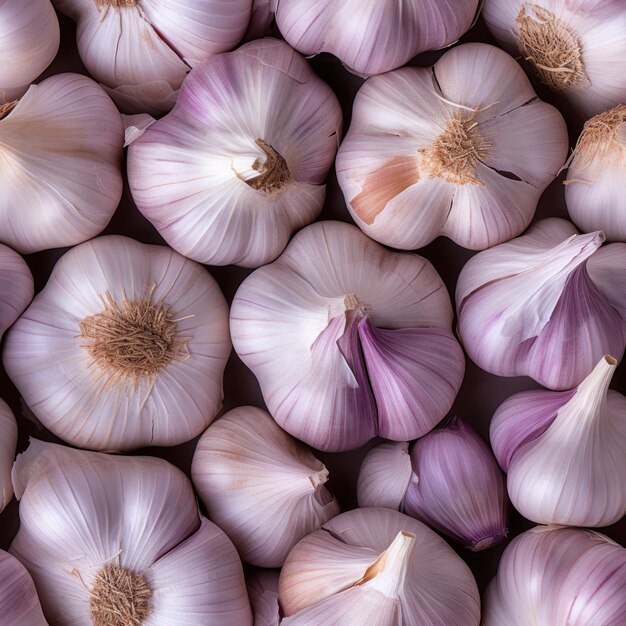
10,440,252,626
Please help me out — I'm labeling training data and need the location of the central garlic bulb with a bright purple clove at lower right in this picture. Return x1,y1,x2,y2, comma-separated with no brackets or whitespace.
230,222,465,451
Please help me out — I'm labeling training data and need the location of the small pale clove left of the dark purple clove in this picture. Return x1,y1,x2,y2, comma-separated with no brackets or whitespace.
357,441,413,511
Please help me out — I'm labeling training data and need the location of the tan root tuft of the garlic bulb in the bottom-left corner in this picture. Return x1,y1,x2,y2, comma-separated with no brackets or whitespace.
89,564,151,626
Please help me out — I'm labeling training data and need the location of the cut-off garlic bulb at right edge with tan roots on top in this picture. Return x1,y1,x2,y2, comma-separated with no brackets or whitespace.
565,104,626,241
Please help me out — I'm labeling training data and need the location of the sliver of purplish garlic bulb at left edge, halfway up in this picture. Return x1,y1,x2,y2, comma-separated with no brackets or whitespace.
0,241,34,337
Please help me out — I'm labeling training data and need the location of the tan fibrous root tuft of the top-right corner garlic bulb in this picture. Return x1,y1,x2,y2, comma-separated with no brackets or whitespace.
515,4,589,91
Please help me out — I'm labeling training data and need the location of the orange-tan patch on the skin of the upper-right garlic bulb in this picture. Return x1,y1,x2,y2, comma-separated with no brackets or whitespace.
350,156,420,225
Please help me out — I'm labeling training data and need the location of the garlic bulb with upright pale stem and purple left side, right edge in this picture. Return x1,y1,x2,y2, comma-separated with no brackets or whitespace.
491,355,626,526
